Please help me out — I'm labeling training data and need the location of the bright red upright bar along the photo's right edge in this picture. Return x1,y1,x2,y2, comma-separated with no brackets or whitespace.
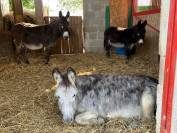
160,0,177,133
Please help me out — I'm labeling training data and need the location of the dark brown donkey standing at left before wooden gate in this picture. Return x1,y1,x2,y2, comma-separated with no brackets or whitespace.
11,11,70,64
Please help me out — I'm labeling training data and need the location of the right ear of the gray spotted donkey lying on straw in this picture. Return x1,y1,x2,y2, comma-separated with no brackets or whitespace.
67,67,76,85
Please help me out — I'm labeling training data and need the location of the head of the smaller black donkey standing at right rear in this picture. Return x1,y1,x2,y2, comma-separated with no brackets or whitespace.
133,20,147,45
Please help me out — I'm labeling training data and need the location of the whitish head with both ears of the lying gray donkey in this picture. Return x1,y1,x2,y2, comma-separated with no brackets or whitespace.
52,68,78,123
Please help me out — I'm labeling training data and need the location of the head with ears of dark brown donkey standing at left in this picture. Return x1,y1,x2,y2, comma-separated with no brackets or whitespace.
59,11,70,39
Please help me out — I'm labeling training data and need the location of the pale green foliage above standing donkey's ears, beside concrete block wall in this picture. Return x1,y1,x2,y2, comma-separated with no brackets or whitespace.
58,0,83,12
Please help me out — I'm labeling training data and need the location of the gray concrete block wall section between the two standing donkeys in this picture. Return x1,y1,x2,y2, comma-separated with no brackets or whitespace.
83,0,109,53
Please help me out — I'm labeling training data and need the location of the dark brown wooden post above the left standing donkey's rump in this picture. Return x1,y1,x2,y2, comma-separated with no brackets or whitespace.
12,0,23,23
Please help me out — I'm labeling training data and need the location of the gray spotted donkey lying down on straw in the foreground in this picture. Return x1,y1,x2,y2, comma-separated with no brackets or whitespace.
53,68,157,124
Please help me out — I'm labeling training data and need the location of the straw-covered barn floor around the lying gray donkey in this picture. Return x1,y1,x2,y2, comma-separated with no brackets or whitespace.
0,37,159,133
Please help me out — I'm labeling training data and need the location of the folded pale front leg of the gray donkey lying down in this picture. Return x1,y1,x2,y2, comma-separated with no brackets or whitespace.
75,112,104,125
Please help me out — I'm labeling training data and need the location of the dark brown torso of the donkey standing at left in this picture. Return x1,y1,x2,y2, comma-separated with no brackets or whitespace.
12,23,58,46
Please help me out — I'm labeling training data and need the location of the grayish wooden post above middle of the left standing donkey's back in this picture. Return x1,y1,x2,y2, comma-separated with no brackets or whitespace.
34,0,44,24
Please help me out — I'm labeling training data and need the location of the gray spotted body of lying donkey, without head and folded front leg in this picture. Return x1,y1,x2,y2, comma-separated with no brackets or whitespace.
77,75,157,118
